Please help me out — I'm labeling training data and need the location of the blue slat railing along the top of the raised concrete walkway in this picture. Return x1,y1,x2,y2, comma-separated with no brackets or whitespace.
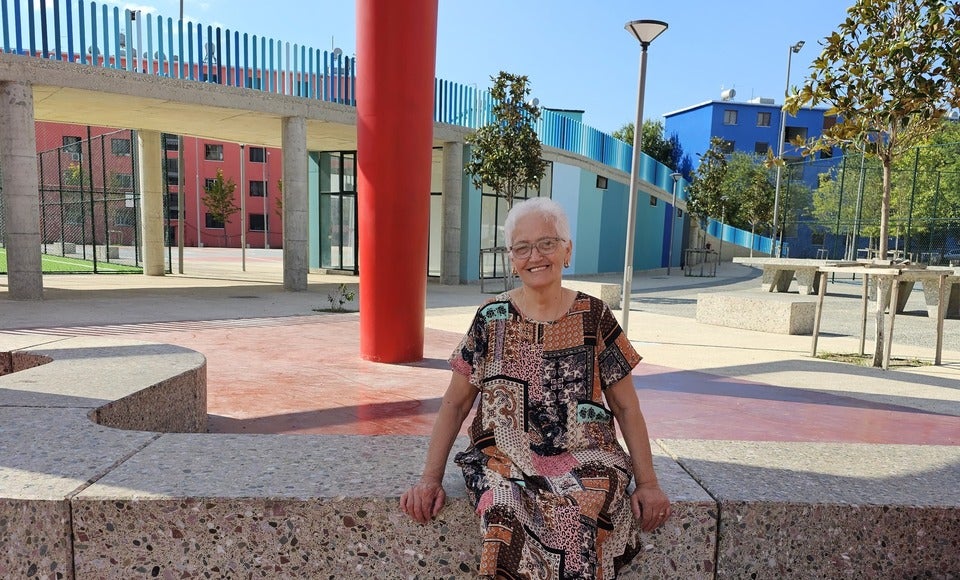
0,0,704,208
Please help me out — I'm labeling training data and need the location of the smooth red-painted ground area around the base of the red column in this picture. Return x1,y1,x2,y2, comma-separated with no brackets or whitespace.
60,314,960,445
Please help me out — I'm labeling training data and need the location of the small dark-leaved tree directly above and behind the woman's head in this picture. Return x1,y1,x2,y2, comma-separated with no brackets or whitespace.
466,71,547,208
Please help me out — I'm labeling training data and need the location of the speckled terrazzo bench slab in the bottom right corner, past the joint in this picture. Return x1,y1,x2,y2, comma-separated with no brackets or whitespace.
657,440,960,580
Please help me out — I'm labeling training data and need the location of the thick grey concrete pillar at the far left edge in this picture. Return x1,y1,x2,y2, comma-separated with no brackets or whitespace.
0,82,43,300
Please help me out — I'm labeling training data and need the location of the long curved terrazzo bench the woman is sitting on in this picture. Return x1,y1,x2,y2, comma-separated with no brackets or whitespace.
0,334,960,579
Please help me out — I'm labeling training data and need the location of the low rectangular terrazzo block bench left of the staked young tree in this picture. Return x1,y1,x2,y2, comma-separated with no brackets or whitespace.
697,290,817,334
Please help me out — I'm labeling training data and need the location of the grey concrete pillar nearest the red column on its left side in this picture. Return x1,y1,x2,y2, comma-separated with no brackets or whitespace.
281,117,310,292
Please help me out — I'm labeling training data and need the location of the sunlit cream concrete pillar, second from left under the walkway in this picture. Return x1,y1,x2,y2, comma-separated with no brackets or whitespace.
137,131,166,276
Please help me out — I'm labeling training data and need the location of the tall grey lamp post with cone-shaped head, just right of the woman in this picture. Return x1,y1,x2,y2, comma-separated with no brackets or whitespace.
620,20,667,335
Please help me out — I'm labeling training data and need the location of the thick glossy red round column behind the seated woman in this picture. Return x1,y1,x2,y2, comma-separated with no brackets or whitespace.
357,0,438,363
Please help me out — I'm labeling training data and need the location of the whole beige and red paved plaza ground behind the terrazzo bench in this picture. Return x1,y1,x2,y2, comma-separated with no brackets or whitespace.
0,248,960,445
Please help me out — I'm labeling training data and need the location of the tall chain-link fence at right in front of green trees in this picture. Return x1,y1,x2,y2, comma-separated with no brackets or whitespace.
784,143,960,265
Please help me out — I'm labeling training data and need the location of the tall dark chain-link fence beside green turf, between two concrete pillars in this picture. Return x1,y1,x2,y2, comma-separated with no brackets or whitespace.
0,123,143,273
